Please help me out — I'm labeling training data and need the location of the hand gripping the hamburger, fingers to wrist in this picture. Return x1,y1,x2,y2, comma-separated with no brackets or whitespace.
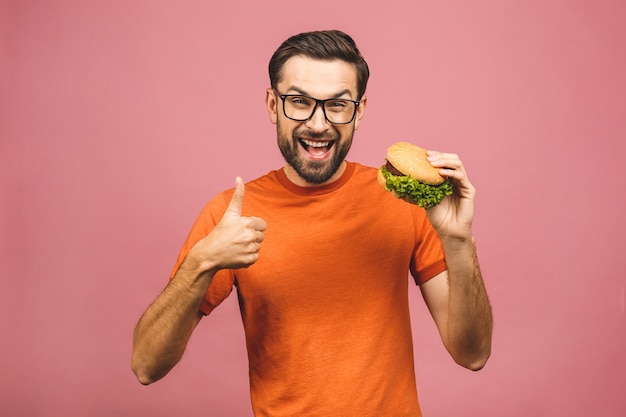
427,151,476,239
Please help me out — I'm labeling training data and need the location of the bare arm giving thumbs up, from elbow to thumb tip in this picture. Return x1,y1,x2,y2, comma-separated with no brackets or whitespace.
131,178,267,384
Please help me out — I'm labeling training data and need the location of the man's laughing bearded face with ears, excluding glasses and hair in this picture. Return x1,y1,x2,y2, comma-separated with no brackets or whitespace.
266,56,366,186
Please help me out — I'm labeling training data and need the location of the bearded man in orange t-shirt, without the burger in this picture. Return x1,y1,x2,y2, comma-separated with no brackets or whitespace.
132,31,492,417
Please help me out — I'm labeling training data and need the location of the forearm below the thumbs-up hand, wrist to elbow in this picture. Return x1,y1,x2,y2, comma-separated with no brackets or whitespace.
131,260,214,384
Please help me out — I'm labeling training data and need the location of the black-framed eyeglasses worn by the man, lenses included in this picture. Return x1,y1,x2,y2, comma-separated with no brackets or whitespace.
274,90,360,125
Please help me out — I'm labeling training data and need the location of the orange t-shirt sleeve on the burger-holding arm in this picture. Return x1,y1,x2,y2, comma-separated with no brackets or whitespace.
410,207,447,285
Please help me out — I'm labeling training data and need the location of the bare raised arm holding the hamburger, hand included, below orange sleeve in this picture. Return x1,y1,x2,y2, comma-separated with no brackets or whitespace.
421,152,493,370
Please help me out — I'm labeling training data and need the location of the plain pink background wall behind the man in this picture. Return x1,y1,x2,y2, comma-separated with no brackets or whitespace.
0,0,626,417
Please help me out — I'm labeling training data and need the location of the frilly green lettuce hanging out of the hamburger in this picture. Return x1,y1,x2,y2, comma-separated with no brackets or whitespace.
381,166,452,209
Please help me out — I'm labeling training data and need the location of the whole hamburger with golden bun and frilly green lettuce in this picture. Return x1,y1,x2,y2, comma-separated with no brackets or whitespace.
377,142,452,209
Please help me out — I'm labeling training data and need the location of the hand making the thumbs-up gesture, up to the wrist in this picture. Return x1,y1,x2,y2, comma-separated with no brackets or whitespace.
193,177,267,269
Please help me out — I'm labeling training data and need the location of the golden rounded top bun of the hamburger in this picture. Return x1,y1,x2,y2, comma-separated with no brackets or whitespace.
387,142,444,185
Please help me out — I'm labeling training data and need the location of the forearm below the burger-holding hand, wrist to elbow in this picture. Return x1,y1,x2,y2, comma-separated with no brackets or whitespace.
442,237,493,370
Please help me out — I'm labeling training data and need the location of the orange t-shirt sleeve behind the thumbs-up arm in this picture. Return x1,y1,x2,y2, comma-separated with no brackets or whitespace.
169,193,235,314
